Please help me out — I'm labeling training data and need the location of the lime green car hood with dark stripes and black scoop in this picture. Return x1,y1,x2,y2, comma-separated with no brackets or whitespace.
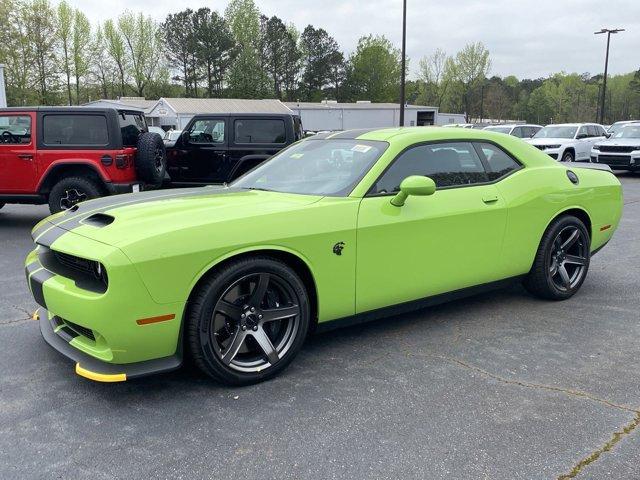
42,186,322,247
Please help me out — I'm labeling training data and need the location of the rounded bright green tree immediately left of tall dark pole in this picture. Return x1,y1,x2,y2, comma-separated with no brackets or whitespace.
347,35,401,102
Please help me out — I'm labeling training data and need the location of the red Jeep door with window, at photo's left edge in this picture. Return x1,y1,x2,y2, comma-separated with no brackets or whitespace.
0,112,38,194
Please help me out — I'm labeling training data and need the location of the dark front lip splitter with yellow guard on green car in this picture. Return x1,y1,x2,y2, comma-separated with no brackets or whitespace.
37,308,182,382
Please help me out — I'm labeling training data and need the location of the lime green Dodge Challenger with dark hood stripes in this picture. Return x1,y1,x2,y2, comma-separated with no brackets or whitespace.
26,127,622,385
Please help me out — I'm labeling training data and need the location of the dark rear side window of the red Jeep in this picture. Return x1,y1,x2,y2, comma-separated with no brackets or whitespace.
42,114,109,146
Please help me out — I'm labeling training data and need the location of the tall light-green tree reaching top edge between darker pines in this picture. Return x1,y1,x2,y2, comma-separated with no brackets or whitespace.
225,0,269,98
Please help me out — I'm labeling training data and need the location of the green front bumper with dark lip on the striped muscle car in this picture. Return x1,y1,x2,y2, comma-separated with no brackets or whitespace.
25,224,185,381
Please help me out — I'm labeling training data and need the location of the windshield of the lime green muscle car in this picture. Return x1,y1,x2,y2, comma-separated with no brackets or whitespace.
231,137,389,196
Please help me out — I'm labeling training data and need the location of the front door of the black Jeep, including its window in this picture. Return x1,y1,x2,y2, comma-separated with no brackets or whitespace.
169,116,229,184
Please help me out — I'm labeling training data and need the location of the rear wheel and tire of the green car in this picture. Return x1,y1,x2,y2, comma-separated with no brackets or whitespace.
523,215,591,300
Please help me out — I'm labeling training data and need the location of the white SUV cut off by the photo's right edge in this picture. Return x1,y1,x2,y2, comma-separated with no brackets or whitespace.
591,122,640,171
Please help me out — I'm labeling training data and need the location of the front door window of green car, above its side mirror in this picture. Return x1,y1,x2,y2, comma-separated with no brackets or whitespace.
373,142,489,193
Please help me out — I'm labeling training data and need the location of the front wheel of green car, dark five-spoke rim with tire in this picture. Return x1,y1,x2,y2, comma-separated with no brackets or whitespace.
185,256,310,385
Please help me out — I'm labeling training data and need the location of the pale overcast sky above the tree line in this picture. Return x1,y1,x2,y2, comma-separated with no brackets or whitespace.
69,0,640,79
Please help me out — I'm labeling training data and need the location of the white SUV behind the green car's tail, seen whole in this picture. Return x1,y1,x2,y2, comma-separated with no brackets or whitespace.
527,123,607,162
